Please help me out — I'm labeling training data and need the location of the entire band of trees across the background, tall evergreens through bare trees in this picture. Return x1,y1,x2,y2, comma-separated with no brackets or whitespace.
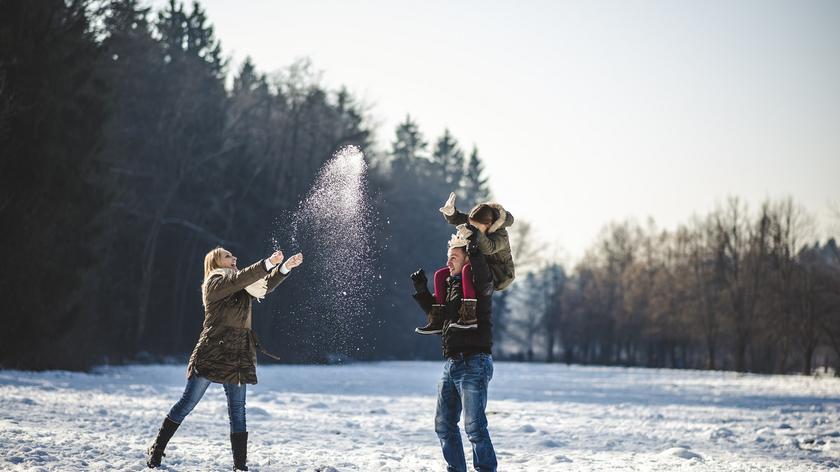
0,0,840,372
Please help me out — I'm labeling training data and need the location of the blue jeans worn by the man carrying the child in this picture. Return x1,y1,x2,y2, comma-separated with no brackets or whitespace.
435,354,496,472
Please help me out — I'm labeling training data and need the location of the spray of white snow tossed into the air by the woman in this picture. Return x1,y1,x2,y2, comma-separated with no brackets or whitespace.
272,146,375,355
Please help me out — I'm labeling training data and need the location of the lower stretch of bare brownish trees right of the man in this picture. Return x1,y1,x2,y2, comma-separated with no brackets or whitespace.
508,198,840,374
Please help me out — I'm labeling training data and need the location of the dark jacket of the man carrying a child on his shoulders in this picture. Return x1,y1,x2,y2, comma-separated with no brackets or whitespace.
414,242,493,357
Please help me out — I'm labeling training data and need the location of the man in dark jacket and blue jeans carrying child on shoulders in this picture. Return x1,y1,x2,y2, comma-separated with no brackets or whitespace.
411,227,496,472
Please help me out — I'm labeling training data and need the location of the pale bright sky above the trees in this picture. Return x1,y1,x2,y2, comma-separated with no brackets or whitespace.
152,0,840,262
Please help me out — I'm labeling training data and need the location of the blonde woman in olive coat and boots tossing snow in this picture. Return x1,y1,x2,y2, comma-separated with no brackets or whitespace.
146,247,303,470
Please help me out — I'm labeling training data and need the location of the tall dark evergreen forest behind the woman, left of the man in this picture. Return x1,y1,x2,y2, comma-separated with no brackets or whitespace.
0,0,496,369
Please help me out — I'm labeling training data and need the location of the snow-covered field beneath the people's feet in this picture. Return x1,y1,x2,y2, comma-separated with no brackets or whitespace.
0,362,840,471
